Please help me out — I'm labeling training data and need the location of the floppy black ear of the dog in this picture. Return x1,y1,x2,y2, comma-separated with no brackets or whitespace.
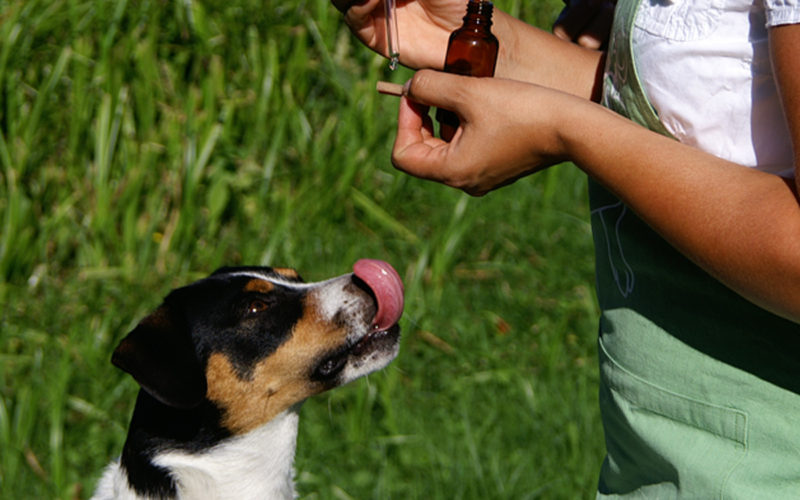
111,305,207,409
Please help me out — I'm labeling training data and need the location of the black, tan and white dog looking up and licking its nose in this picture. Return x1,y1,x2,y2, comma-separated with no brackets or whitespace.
92,259,404,500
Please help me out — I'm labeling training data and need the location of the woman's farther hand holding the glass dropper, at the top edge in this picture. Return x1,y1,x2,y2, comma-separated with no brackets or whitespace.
331,0,466,69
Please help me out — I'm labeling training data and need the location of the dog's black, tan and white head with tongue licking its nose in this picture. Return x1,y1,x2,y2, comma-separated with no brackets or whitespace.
112,259,403,434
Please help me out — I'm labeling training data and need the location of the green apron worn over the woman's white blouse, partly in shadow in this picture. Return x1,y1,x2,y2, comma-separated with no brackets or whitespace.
590,0,800,500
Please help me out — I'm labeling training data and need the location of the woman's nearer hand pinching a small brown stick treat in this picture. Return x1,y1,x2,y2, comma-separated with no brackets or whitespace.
392,70,580,195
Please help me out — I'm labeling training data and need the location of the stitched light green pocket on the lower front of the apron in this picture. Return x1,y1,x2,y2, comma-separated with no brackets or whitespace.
598,339,747,498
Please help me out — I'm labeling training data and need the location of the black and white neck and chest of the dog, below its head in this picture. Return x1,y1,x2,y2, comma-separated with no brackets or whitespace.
95,394,300,500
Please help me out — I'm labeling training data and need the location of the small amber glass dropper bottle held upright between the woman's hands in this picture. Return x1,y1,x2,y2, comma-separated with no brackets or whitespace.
436,0,500,141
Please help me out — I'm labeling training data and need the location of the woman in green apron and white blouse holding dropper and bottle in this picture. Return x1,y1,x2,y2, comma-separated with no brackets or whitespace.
333,0,800,499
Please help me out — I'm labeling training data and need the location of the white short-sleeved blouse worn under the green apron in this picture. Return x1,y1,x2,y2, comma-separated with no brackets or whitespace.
633,0,800,177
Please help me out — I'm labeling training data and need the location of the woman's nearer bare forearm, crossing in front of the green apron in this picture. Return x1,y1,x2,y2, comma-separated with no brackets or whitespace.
562,102,800,322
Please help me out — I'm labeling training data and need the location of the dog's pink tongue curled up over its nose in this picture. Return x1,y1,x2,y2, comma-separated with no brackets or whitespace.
353,259,403,330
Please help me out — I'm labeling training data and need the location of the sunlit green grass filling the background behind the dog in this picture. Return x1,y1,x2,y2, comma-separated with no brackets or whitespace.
0,0,602,500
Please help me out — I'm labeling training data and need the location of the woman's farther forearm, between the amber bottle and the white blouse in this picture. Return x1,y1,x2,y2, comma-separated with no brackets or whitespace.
492,11,605,101
